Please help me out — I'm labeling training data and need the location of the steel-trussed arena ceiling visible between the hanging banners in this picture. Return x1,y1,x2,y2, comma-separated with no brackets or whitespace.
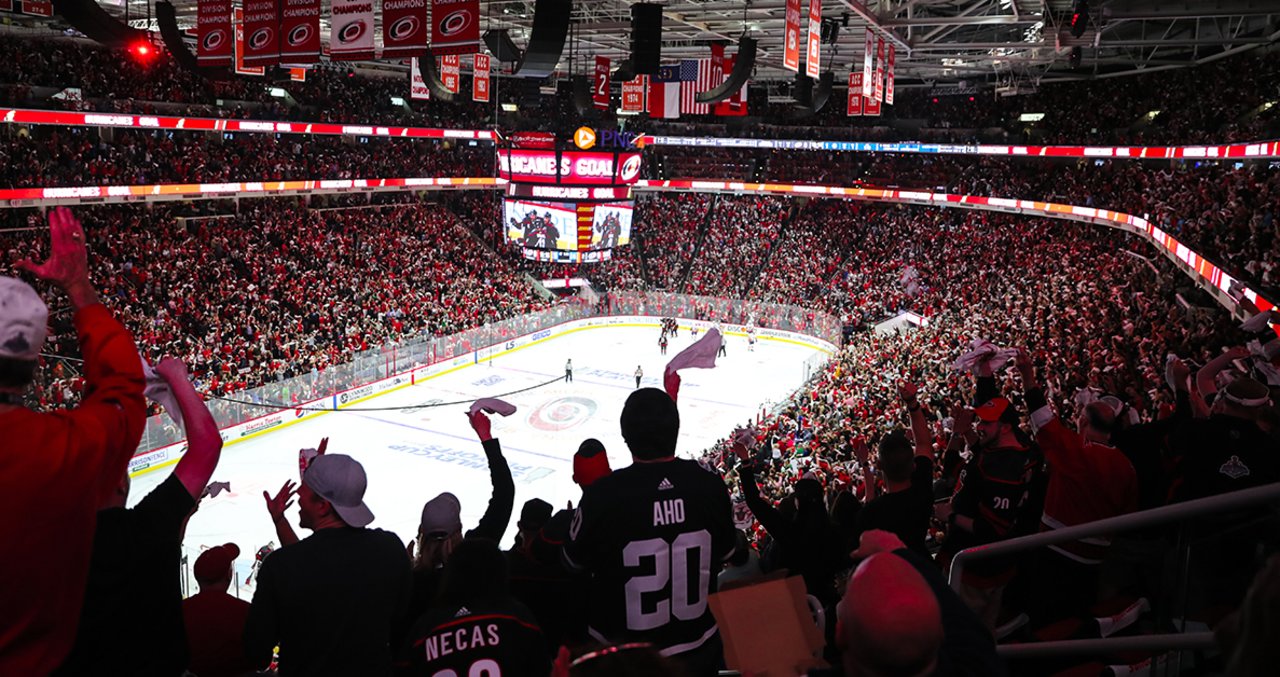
87,0,1280,87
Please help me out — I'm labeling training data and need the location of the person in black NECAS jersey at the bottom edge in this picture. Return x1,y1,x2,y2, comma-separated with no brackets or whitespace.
397,539,550,677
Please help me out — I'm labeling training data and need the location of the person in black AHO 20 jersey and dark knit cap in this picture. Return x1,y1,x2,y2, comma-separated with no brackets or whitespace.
564,388,735,674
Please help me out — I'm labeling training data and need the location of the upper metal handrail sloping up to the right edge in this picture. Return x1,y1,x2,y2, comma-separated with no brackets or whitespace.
948,482,1280,590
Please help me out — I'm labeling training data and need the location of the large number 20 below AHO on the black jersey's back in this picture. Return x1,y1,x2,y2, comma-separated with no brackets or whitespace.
622,529,712,631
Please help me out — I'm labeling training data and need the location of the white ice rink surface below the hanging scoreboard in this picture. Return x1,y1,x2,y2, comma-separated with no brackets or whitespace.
129,328,819,598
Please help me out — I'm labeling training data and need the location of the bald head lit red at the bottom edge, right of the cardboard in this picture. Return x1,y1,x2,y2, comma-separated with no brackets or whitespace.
840,553,942,677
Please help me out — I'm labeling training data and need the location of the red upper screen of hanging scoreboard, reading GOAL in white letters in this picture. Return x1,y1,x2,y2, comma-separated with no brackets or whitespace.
498,148,640,186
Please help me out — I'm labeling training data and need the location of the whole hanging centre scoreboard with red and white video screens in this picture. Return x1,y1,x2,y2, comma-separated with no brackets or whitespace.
498,127,644,264
